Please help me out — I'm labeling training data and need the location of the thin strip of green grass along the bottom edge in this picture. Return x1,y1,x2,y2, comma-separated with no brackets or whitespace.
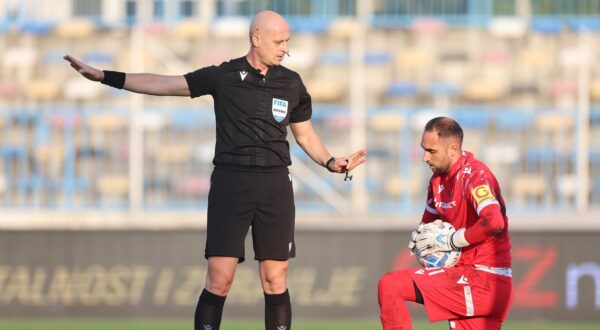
0,319,600,330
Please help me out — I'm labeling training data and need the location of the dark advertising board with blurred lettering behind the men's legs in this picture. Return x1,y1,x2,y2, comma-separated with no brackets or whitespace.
0,228,600,320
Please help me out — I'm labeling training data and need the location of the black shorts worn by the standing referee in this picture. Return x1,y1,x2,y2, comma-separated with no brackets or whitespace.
204,167,296,262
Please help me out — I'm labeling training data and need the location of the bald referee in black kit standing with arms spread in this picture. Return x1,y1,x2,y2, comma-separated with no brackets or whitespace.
64,11,366,330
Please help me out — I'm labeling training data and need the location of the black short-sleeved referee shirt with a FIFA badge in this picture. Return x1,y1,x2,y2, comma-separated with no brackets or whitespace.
185,57,312,167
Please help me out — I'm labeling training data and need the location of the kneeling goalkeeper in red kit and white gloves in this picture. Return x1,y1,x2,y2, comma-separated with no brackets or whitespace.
378,117,512,330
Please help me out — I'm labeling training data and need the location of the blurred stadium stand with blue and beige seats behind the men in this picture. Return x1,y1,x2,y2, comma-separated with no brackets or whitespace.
0,0,600,214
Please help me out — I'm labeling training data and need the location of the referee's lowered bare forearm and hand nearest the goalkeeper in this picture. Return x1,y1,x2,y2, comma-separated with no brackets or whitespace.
290,119,367,173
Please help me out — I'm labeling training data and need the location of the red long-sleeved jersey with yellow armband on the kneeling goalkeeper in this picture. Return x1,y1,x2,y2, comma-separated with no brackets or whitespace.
422,151,511,267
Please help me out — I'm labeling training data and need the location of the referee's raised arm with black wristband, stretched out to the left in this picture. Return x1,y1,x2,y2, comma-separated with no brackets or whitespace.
63,55,190,96
